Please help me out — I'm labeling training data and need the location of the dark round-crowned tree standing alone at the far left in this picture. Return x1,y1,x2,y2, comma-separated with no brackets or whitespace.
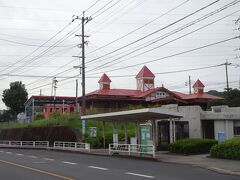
2,81,28,116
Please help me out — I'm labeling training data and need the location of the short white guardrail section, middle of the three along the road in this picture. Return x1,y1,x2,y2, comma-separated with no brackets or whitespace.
53,141,90,152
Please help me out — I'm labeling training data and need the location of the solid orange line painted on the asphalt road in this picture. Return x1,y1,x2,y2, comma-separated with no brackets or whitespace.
0,160,73,180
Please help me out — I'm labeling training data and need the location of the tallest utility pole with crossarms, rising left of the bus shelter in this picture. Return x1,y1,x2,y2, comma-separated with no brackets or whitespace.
73,12,92,115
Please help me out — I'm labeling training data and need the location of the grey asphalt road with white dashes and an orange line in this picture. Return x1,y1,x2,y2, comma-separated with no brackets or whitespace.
0,149,240,180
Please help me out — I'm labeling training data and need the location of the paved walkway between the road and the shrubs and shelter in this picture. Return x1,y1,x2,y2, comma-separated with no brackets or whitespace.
87,149,240,176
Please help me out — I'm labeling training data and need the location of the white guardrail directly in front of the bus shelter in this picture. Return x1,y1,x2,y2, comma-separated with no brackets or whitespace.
109,144,155,158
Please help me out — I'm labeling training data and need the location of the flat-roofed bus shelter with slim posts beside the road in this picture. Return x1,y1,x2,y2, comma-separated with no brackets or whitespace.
81,108,182,155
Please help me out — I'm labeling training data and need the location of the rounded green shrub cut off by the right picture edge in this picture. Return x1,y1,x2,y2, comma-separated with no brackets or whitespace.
210,138,240,159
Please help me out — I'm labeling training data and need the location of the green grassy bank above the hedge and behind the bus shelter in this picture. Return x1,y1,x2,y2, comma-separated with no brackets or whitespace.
1,113,136,147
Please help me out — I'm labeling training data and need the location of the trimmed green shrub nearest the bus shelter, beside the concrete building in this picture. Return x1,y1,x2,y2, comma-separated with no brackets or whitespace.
169,139,217,155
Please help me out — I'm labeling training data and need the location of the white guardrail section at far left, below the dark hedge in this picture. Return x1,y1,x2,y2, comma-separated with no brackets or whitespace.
0,141,49,148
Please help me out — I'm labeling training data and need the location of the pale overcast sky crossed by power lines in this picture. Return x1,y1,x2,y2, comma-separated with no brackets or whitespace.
0,0,240,109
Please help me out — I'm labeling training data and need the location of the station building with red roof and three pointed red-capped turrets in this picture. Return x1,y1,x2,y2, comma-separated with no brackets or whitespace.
79,66,222,112
